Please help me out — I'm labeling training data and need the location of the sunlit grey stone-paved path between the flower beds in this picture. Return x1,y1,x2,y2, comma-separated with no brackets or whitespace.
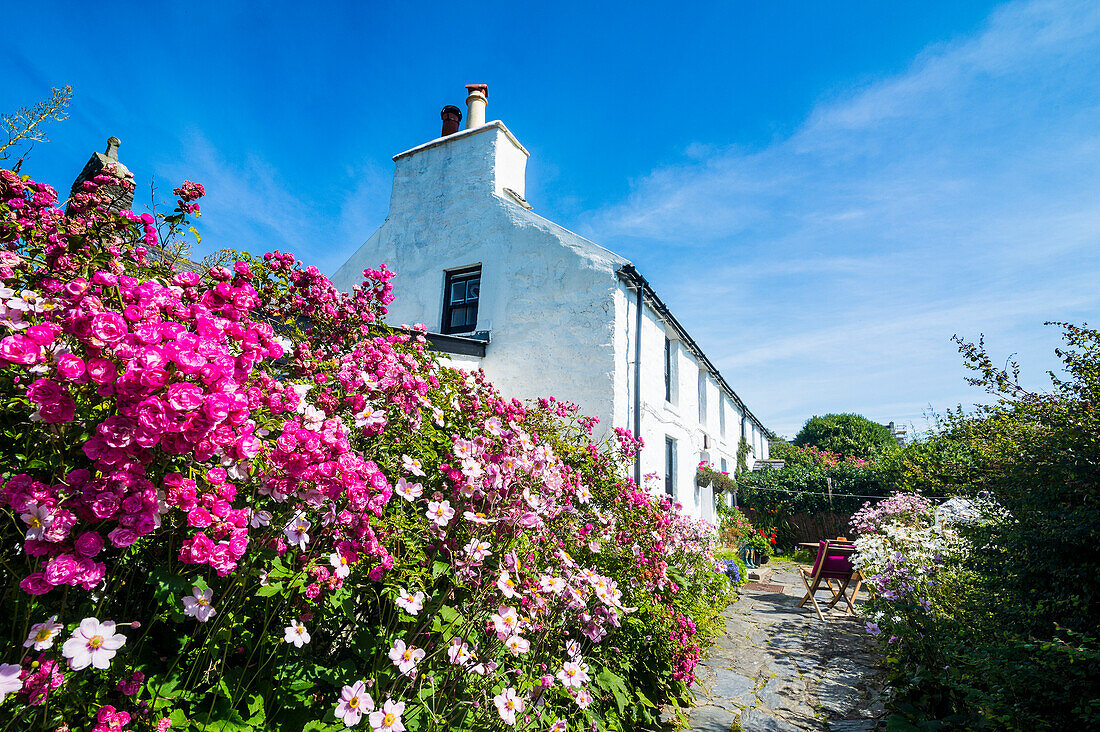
690,561,884,732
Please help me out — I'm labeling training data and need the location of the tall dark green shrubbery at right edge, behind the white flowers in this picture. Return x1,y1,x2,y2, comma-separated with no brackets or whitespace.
866,324,1100,730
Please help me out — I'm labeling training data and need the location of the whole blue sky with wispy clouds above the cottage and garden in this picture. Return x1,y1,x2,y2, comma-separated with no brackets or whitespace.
0,0,1100,435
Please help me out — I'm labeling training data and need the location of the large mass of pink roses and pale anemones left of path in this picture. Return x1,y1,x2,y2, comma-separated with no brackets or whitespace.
0,162,729,732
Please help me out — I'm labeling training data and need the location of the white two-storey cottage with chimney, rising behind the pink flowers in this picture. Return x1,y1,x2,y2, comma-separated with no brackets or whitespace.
332,85,768,520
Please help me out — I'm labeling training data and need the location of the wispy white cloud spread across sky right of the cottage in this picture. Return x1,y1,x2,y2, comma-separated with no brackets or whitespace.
581,0,1100,434
